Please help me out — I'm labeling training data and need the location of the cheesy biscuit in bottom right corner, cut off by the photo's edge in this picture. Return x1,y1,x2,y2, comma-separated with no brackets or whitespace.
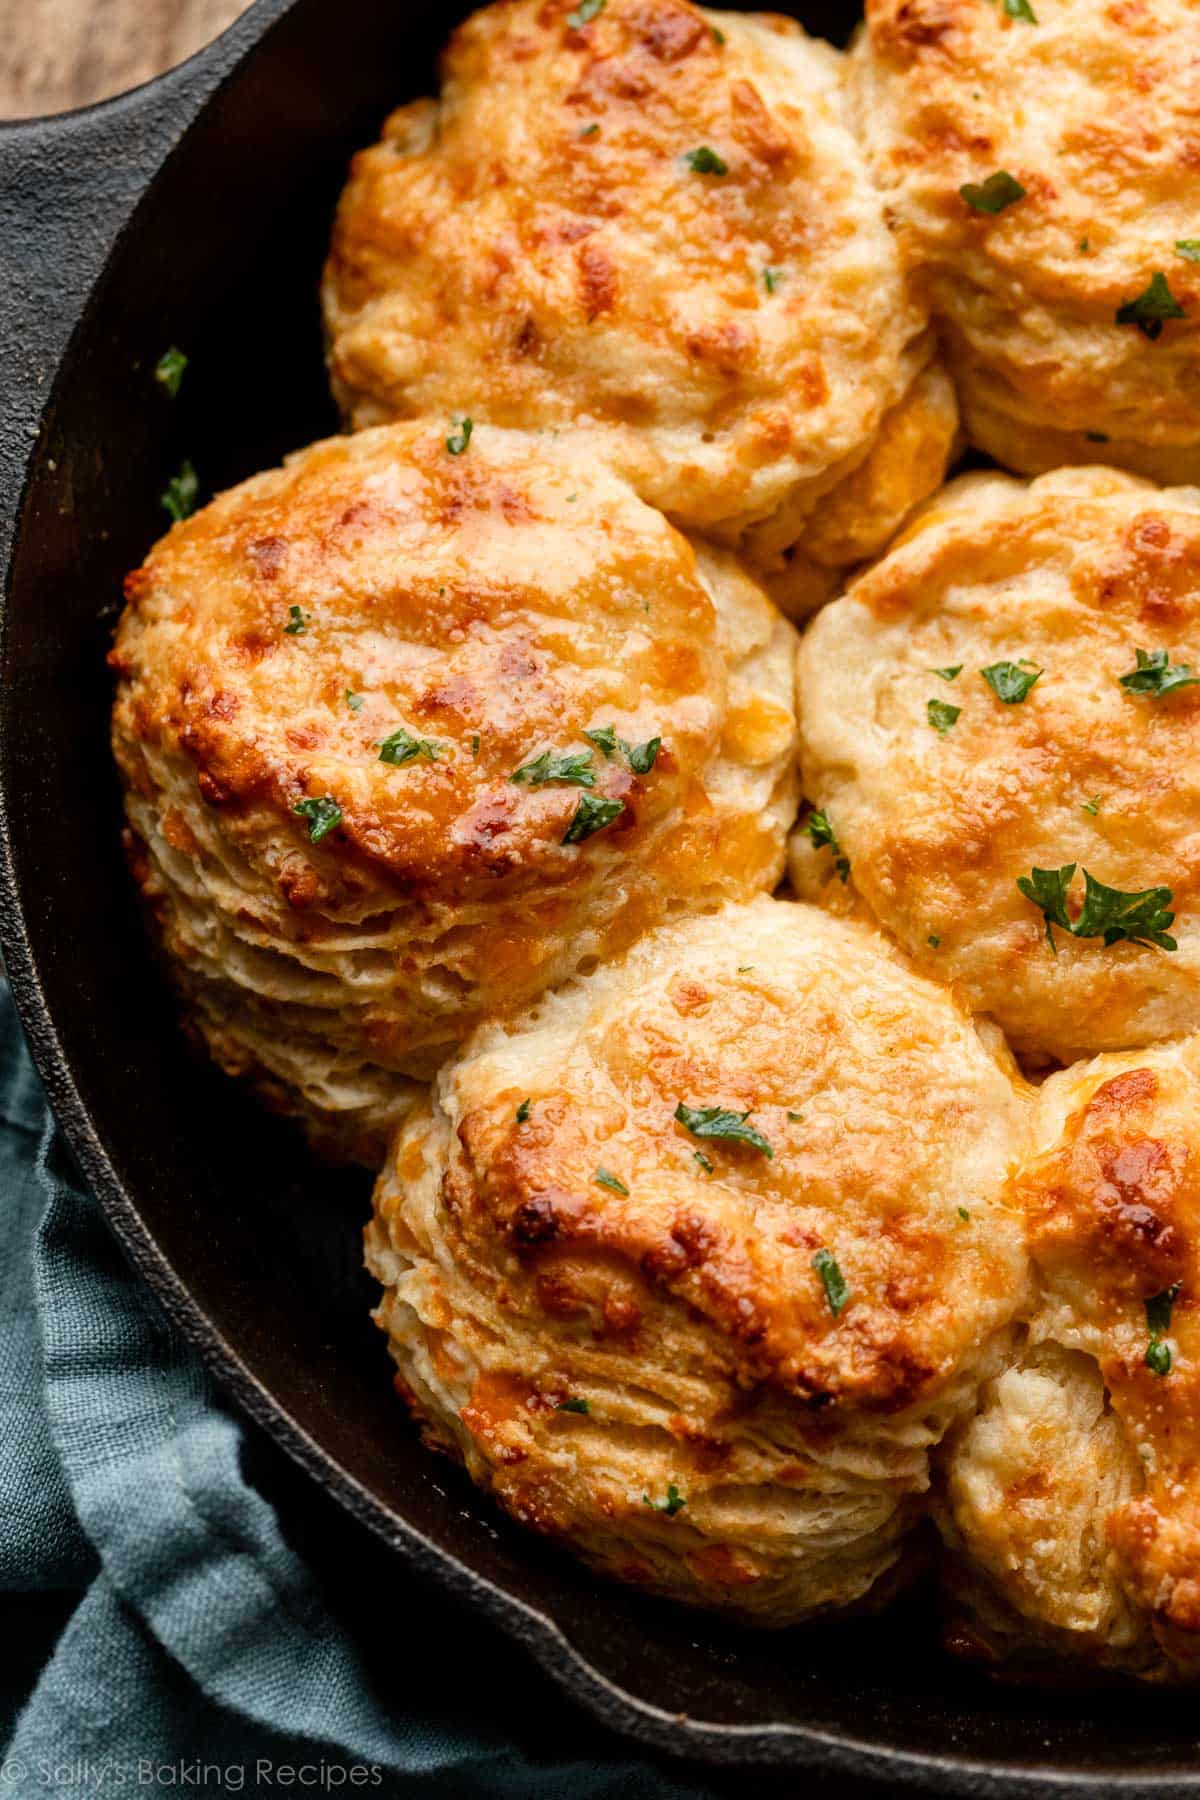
945,1037,1200,1681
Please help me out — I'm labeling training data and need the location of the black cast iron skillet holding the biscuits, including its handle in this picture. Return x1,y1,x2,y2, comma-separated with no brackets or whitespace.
0,0,1200,1800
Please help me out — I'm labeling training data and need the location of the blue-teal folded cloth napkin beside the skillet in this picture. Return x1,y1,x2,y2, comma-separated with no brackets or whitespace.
0,994,716,1800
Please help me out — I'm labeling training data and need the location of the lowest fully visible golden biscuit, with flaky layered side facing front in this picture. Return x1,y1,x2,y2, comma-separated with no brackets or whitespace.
367,898,1025,1624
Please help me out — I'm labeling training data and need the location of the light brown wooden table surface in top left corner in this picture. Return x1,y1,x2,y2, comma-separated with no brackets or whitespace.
0,0,248,119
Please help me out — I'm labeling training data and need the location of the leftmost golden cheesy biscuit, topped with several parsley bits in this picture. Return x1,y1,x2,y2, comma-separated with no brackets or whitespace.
112,425,795,1154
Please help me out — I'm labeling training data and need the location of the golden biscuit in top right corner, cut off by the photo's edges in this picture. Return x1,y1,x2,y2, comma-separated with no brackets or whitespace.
849,0,1200,482
